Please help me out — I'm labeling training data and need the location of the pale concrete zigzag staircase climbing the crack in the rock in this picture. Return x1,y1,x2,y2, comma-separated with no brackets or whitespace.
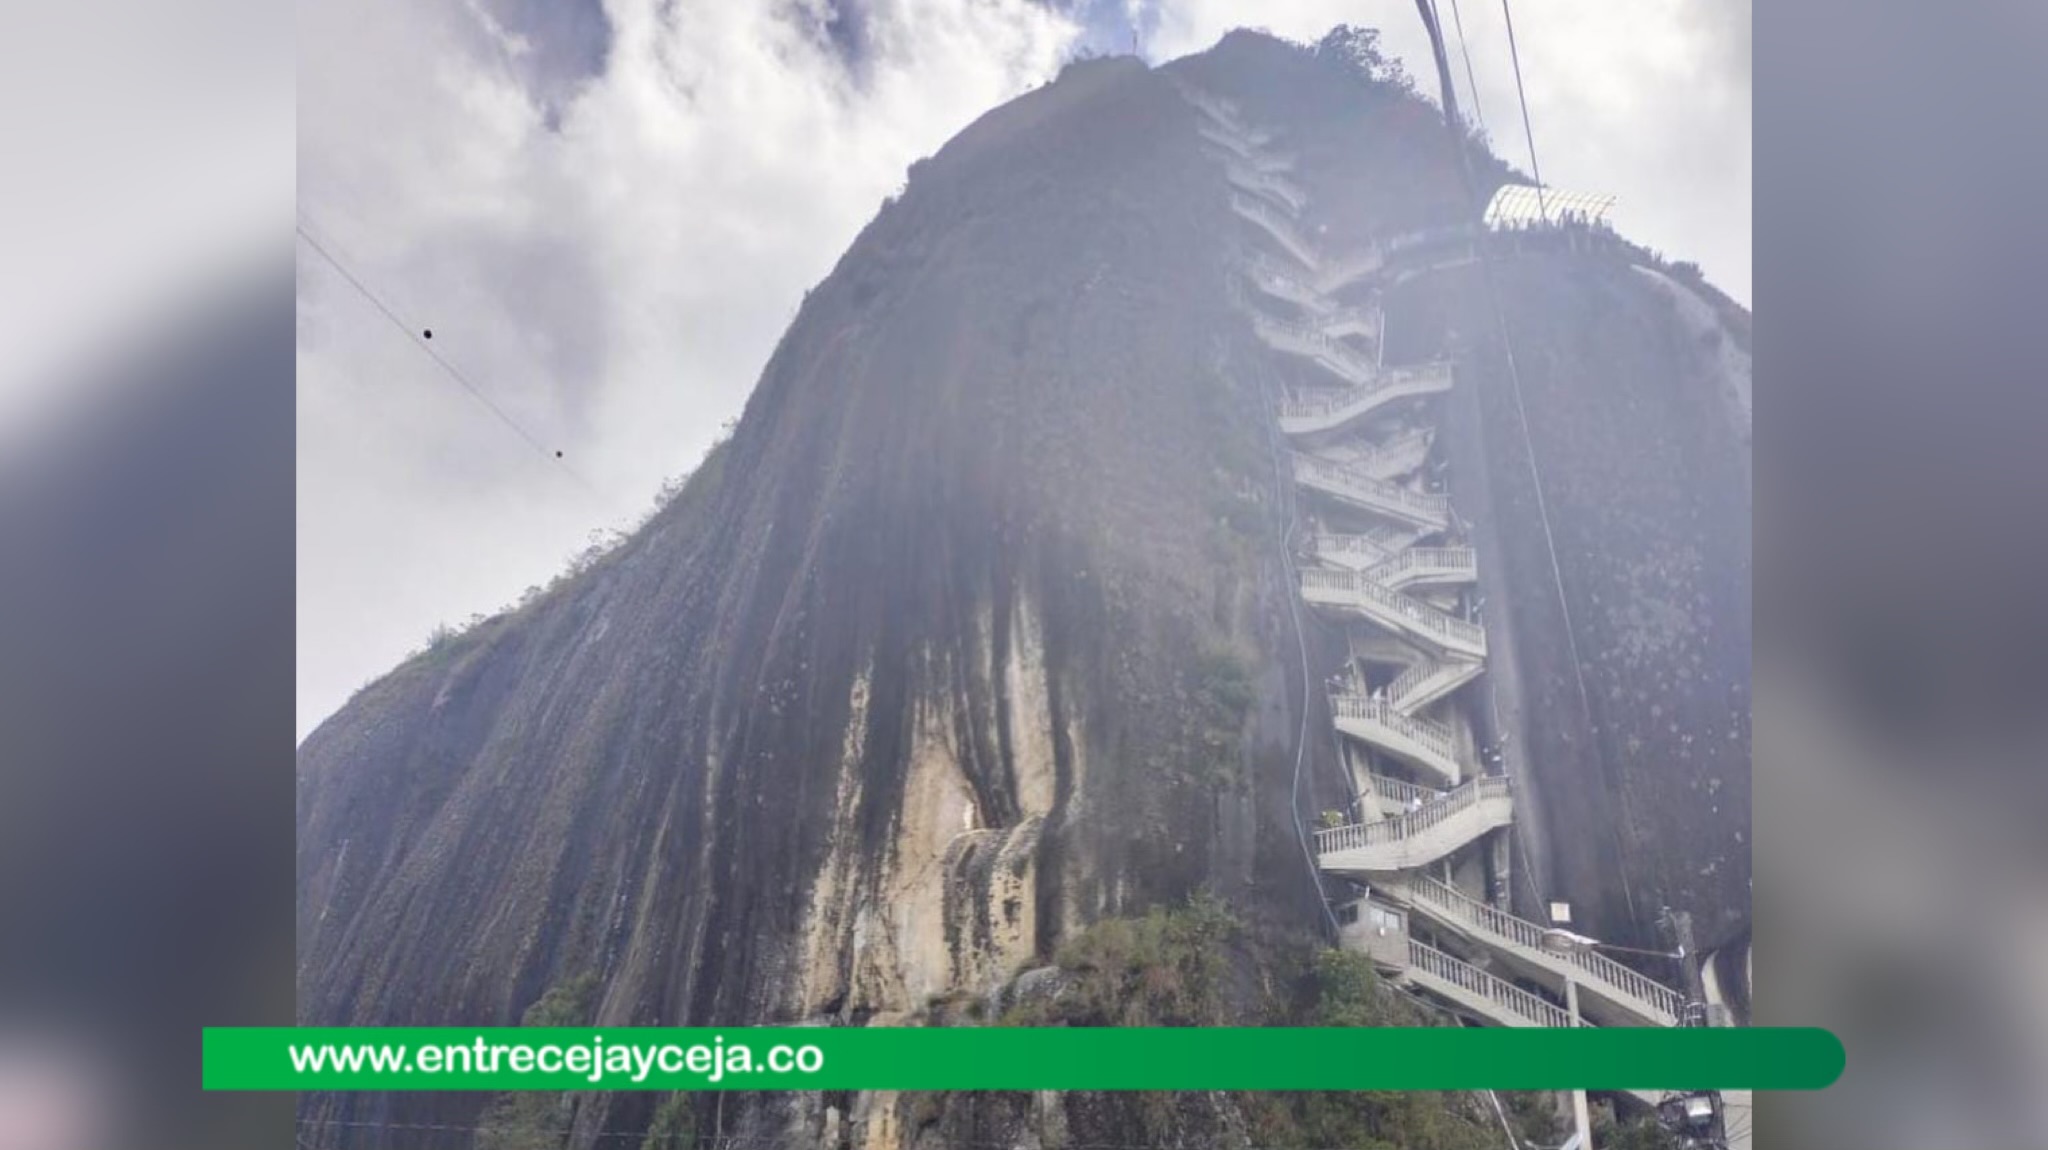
1190,94,1683,1072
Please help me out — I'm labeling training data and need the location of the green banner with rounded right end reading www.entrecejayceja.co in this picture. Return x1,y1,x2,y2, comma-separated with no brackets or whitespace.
203,1027,1845,1093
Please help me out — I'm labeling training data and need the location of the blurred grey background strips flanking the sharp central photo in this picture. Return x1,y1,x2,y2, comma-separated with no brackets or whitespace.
0,0,2048,1150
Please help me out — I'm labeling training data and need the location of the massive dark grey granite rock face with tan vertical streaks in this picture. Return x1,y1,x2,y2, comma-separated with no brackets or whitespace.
299,33,1749,1148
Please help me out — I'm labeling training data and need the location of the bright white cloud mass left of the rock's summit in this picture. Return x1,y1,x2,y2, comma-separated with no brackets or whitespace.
299,0,1079,735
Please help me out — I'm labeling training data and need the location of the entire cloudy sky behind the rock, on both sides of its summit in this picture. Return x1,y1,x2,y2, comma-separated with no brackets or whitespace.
297,0,1749,737
